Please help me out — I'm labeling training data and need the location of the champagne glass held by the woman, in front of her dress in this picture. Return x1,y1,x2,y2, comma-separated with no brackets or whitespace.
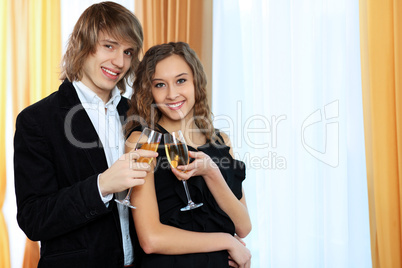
163,130,203,211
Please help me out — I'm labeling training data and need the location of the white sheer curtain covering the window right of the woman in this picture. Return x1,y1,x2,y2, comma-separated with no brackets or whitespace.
212,0,371,268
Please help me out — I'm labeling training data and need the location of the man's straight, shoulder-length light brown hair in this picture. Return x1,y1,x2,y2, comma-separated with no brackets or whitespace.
60,2,144,93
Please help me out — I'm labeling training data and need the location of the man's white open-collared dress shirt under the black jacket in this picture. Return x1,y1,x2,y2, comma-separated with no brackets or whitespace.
73,81,134,265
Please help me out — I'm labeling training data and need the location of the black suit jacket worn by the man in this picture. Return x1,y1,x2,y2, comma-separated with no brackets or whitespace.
14,80,134,268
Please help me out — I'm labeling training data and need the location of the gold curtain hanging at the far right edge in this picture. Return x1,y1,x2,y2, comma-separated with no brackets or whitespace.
360,0,402,268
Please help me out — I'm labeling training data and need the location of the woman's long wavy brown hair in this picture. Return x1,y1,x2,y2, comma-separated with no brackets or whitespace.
125,42,216,141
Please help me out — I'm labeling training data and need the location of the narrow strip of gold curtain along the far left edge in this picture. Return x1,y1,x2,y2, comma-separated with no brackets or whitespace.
0,1,10,268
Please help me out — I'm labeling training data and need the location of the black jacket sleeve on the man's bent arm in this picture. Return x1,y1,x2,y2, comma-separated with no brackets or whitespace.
14,109,111,241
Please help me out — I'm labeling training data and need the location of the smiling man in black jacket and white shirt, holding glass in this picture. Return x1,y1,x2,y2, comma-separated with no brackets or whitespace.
14,2,153,268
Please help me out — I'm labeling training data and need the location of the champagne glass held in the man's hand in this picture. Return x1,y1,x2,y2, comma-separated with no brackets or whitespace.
114,128,162,209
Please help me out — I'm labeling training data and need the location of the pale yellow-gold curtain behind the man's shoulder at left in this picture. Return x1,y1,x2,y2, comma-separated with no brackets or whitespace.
8,0,61,268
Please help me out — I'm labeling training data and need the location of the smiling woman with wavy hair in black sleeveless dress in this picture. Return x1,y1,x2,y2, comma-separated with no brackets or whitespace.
126,42,251,267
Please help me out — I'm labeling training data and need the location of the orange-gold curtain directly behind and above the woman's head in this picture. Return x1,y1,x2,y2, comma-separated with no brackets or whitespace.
135,0,212,104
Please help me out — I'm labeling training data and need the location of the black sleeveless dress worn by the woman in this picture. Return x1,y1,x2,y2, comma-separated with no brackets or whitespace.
133,126,245,268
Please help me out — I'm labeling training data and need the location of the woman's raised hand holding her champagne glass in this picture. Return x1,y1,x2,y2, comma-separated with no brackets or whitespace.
172,151,220,180
